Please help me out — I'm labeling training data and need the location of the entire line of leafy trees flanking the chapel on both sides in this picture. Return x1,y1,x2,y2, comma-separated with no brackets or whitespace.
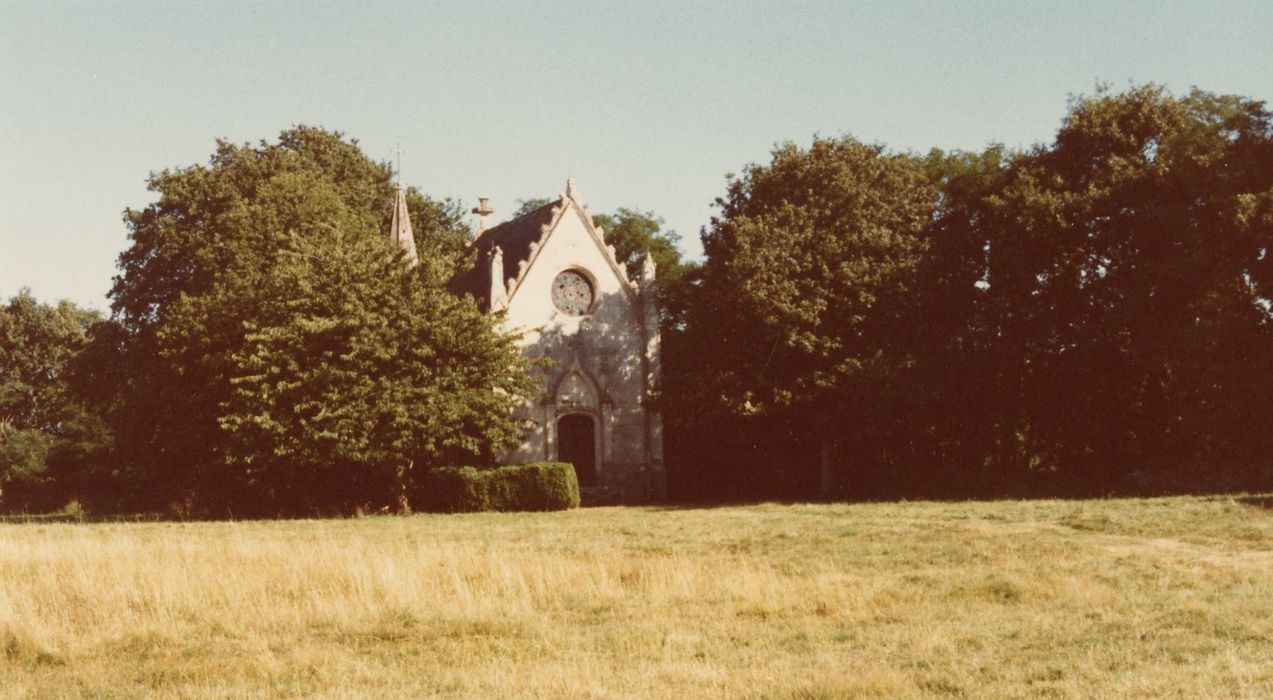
0,85,1273,515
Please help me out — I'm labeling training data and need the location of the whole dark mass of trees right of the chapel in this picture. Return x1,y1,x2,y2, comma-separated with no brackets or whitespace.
665,85,1273,498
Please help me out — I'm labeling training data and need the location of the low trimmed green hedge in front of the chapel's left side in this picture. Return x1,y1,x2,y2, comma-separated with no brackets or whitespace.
421,462,579,513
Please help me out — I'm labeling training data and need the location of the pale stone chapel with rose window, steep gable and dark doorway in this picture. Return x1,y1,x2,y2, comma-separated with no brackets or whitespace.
414,179,666,503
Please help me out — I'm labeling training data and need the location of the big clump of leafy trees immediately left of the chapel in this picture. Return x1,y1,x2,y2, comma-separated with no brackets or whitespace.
85,127,532,519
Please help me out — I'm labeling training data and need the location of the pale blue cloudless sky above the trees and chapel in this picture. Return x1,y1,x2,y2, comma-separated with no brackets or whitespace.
0,0,1273,309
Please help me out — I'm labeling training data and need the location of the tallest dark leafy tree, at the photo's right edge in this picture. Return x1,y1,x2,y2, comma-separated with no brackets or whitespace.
962,85,1273,481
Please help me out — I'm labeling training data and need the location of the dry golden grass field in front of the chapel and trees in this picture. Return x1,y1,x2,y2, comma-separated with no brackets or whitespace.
0,496,1273,697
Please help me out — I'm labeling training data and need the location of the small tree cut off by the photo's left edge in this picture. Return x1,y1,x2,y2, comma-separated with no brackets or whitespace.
0,289,102,508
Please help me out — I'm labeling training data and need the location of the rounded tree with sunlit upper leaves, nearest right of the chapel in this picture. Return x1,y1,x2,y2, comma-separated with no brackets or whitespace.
690,137,936,494
